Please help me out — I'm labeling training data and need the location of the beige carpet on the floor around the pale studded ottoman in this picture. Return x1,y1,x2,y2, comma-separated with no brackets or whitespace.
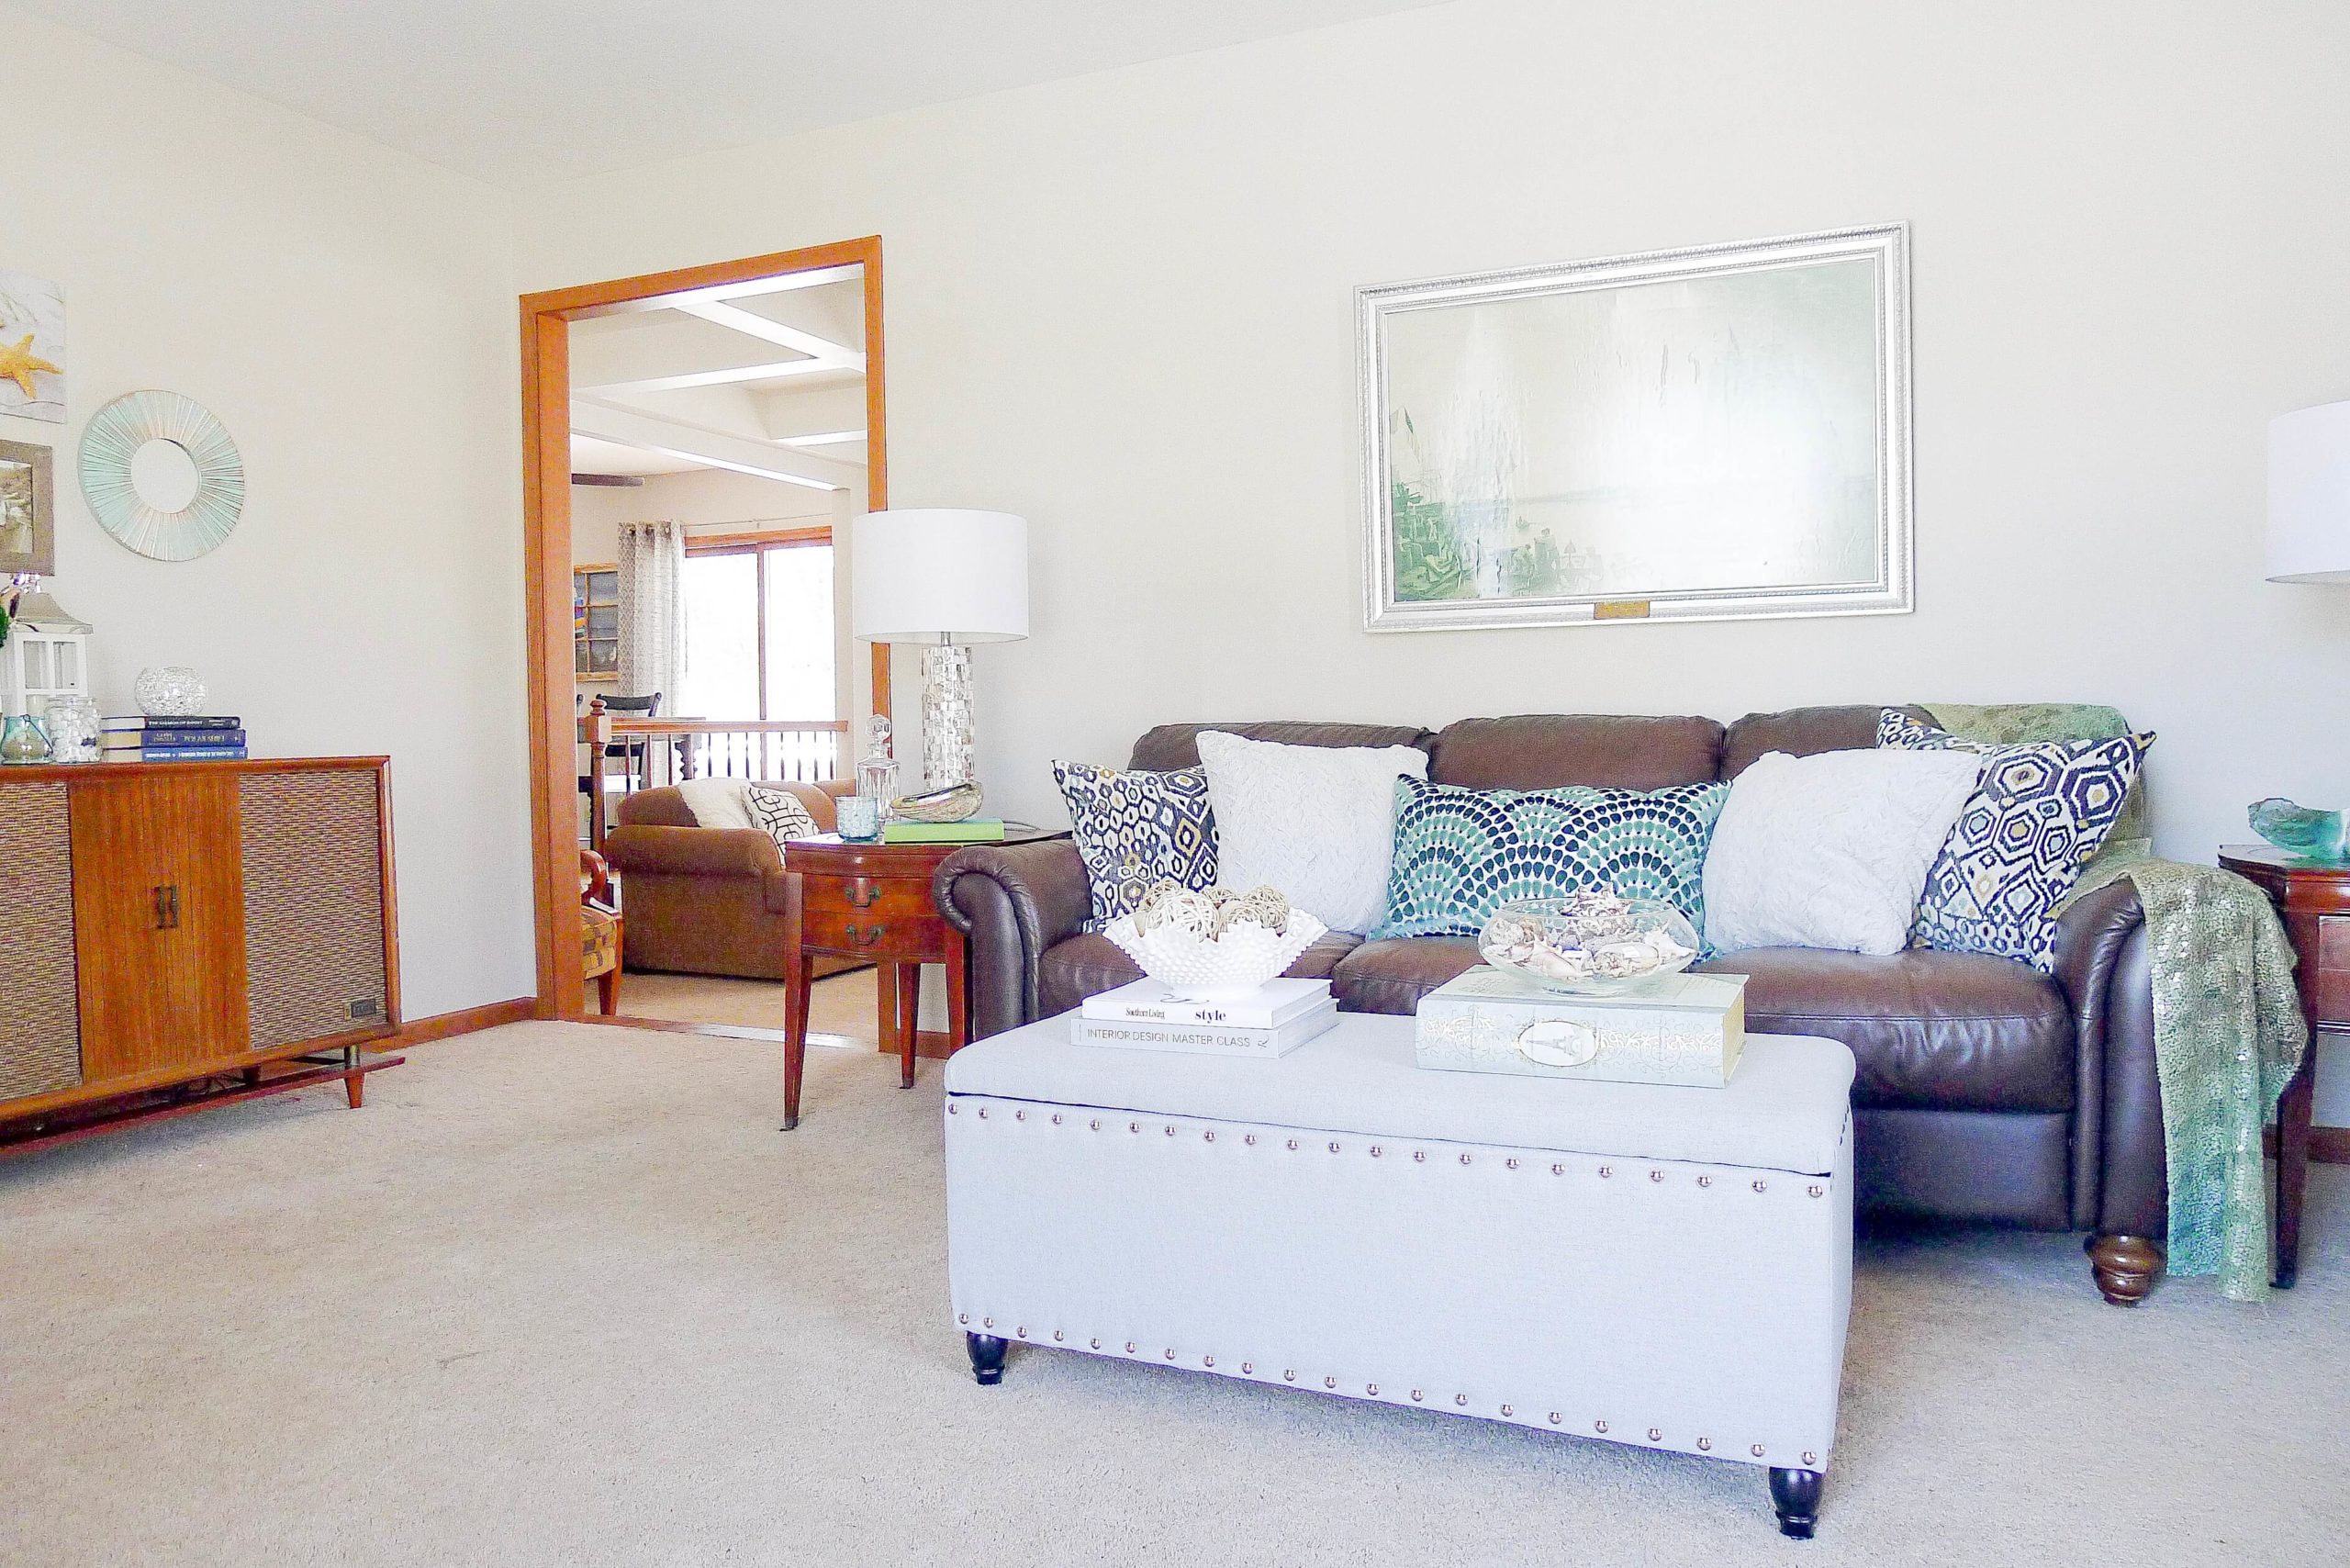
0,1025,2350,1568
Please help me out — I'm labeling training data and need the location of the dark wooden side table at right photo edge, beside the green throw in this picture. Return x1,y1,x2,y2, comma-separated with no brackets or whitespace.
2219,844,2350,1286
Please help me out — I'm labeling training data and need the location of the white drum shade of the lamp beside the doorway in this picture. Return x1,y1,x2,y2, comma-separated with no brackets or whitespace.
848,508,1027,644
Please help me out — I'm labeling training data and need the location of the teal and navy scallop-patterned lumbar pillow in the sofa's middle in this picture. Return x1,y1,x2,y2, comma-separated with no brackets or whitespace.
1372,778,1729,938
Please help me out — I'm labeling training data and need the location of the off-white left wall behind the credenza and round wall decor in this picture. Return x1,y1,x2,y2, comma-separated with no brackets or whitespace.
0,9,536,1018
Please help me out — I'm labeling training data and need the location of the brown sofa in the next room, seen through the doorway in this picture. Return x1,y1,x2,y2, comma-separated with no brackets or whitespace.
604,783,860,980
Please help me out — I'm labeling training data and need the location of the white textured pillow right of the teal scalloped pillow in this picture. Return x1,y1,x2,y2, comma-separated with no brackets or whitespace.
1707,750,1981,955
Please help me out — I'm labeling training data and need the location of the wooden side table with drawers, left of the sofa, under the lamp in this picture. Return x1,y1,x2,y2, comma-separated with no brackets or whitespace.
782,825,1069,1131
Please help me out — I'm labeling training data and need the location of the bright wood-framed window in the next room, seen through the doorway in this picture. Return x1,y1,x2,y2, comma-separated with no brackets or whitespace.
675,529,839,720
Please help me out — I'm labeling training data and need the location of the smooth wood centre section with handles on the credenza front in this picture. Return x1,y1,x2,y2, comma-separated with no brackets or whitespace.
73,771,249,1081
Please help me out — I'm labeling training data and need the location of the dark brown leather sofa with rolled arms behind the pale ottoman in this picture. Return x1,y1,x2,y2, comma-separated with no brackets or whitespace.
930,708,2166,1305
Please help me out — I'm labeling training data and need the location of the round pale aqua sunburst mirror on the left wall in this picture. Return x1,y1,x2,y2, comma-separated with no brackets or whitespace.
83,393,244,562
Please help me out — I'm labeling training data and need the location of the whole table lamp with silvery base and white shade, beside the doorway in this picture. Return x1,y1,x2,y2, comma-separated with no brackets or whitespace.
848,508,1027,790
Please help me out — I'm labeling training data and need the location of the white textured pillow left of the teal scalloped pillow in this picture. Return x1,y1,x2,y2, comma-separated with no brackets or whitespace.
1199,729,1428,931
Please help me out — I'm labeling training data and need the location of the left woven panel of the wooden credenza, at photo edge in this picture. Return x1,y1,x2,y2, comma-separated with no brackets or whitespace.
0,783,83,1100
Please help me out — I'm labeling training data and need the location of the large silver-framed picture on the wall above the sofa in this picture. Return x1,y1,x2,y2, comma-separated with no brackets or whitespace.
1356,223,1913,633
